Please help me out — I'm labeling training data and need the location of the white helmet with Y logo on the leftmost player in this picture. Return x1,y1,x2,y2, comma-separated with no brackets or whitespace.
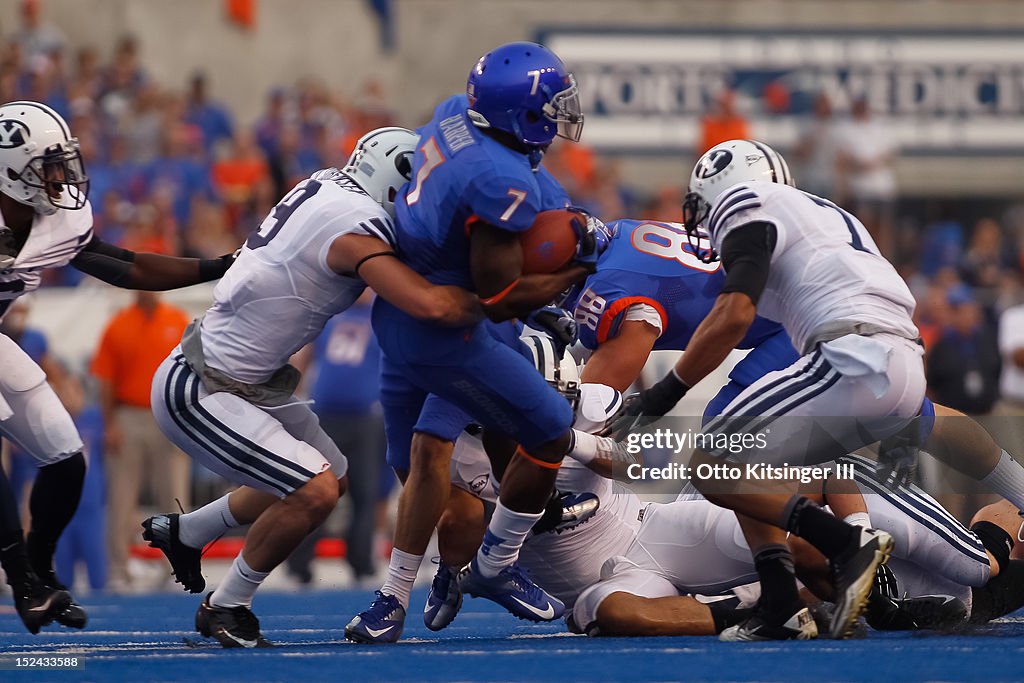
0,101,89,215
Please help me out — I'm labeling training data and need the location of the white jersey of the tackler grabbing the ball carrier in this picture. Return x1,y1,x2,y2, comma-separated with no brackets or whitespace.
202,169,394,384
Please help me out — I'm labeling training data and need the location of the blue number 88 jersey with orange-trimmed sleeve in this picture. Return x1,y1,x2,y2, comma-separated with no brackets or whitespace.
574,219,781,351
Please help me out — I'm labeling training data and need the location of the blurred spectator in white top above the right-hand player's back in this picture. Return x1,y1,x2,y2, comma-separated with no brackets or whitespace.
836,96,898,255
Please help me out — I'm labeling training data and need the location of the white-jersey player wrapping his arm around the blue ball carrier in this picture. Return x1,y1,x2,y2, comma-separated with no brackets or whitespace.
142,128,482,647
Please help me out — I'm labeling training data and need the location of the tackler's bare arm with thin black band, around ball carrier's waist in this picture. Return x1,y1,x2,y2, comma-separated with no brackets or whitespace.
327,234,483,327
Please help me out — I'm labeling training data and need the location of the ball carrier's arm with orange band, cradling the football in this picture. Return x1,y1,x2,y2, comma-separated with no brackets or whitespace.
469,221,591,323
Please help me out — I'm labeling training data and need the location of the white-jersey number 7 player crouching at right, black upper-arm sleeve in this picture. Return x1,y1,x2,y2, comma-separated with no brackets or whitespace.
622,140,1024,639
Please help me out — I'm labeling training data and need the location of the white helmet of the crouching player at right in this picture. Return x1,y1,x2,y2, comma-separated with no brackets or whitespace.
683,140,796,260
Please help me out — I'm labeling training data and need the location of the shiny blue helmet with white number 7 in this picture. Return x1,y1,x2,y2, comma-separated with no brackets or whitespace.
466,43,583,146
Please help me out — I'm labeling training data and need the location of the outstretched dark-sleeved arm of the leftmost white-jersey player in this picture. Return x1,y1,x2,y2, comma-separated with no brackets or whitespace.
71,237,234,291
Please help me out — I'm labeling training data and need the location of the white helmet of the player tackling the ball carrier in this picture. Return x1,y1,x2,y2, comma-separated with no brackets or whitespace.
341,126,420,218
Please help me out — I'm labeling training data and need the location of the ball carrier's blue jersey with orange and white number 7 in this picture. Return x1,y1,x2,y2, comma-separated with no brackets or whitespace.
395,95,568,289
